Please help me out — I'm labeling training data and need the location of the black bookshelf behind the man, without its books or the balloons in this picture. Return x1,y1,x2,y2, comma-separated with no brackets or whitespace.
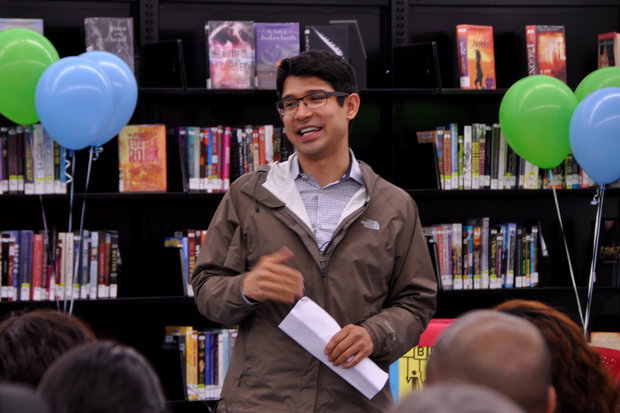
0,0,620,412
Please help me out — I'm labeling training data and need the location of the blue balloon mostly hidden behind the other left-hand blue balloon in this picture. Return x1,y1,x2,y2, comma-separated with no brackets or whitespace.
80,51,138,146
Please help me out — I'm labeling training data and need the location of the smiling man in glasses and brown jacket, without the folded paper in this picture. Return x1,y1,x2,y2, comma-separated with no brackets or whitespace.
192,50,437,413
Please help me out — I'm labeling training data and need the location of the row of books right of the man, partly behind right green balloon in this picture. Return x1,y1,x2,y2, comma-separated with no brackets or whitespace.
417,123,595,190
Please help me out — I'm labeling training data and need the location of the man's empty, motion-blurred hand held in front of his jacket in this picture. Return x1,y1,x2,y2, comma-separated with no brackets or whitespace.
243,247,304,303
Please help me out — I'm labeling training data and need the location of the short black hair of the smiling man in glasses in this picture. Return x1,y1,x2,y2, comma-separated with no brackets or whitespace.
276,50,357,101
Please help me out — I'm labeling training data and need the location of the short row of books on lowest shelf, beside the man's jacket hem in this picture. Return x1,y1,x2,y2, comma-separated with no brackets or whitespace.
164,326,237,400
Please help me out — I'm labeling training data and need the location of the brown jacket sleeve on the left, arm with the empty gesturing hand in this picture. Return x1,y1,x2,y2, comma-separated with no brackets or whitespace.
192,190,255,325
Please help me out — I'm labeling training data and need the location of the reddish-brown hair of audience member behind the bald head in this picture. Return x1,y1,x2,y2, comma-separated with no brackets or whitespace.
496,300,618,413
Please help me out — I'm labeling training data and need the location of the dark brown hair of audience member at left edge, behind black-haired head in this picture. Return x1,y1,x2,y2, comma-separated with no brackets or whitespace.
0,308,96,386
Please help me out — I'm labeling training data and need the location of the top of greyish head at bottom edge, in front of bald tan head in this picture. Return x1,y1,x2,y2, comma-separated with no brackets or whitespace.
393,382,525,413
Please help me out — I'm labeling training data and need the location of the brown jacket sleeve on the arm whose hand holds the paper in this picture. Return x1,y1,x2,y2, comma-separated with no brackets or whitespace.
360,197,437,364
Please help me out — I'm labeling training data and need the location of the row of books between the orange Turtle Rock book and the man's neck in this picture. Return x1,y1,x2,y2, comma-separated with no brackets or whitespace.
172,125,294,193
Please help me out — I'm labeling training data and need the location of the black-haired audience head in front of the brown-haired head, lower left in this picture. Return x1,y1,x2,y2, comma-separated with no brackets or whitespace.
37,341,167,413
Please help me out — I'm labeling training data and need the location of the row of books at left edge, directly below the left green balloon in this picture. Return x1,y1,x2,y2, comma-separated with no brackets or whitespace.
0,124,67,195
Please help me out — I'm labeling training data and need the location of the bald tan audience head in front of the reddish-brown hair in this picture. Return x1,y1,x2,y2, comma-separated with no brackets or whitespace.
426,310,555,413
